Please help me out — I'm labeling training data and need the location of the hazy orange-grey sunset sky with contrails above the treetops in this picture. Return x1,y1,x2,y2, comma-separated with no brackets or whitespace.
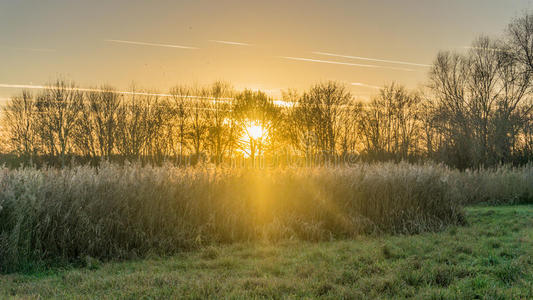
0,0,533,100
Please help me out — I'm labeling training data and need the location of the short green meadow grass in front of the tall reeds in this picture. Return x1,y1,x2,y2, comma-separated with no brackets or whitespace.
0,206,533,299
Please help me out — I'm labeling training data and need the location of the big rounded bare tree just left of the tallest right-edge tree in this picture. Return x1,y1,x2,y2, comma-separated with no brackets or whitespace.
430,37,531,167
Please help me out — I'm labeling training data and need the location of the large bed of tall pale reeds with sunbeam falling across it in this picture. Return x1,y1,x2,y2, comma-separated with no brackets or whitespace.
0,163,470,272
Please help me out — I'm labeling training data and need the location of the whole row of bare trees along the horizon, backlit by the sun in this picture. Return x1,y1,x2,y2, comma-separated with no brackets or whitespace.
1,14,533,169
